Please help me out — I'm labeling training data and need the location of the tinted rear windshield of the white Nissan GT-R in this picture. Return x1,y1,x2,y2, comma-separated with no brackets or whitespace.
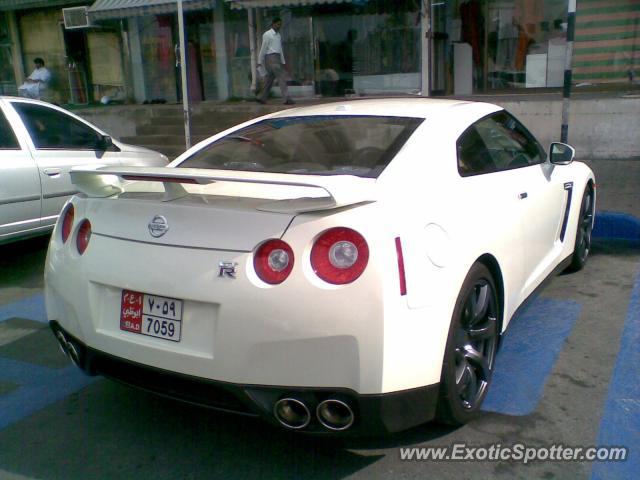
178,115,423,178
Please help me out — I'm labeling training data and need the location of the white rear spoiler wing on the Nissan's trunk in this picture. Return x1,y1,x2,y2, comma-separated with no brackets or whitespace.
70,166,376,213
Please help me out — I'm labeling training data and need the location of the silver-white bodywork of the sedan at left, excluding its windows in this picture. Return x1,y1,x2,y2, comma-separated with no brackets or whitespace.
0,96,168,243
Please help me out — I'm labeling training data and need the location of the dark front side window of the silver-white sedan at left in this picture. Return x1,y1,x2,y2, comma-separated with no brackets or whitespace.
13,102,99,150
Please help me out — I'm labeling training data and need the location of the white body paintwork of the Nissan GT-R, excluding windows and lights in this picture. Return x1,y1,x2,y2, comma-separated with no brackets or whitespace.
45,99,594,436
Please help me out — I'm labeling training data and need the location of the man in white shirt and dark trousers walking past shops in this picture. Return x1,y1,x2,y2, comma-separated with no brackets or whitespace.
256,17,294,105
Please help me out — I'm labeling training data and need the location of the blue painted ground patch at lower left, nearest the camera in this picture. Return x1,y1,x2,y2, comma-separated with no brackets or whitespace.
0,357,96,430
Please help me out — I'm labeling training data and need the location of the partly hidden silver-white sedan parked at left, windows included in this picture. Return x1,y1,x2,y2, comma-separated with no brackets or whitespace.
0,96,168,243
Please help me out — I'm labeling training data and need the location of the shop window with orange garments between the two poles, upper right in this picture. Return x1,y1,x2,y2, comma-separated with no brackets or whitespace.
431,0,567,95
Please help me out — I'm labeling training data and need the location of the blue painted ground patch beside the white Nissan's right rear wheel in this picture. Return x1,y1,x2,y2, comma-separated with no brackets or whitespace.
482,298,580,415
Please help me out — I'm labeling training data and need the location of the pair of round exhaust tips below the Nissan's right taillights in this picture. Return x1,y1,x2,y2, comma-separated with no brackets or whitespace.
273,397,355,432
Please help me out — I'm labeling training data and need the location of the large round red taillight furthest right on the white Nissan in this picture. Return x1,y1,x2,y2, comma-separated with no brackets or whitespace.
311,227,369,285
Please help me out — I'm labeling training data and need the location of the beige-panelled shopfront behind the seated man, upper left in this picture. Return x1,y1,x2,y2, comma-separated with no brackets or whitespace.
0,0,130,105
